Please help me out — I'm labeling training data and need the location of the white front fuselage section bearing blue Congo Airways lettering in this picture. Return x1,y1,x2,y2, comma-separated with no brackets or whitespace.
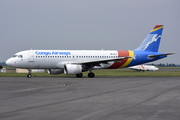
6,50,118,69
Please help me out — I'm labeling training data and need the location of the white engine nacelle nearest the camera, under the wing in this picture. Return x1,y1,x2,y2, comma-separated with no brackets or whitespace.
64,64,82,75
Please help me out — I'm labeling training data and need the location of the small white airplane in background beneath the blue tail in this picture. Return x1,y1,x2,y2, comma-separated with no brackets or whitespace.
129,65,159,72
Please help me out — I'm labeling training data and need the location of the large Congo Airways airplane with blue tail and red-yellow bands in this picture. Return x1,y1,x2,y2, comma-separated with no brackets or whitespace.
6,25,173,78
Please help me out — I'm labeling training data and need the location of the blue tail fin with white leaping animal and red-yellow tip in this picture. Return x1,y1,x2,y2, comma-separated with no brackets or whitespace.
135,25,164,52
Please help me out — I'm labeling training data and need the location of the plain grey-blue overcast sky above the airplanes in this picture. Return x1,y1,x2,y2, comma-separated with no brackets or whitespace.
0,0,180,64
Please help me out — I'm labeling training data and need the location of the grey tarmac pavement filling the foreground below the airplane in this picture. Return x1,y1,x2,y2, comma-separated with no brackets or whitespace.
0,77,180,120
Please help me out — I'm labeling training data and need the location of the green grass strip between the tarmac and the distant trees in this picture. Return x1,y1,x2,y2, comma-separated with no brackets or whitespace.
0,68,180,77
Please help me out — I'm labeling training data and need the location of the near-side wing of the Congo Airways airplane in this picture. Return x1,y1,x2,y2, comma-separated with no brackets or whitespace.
72,56,132,67
